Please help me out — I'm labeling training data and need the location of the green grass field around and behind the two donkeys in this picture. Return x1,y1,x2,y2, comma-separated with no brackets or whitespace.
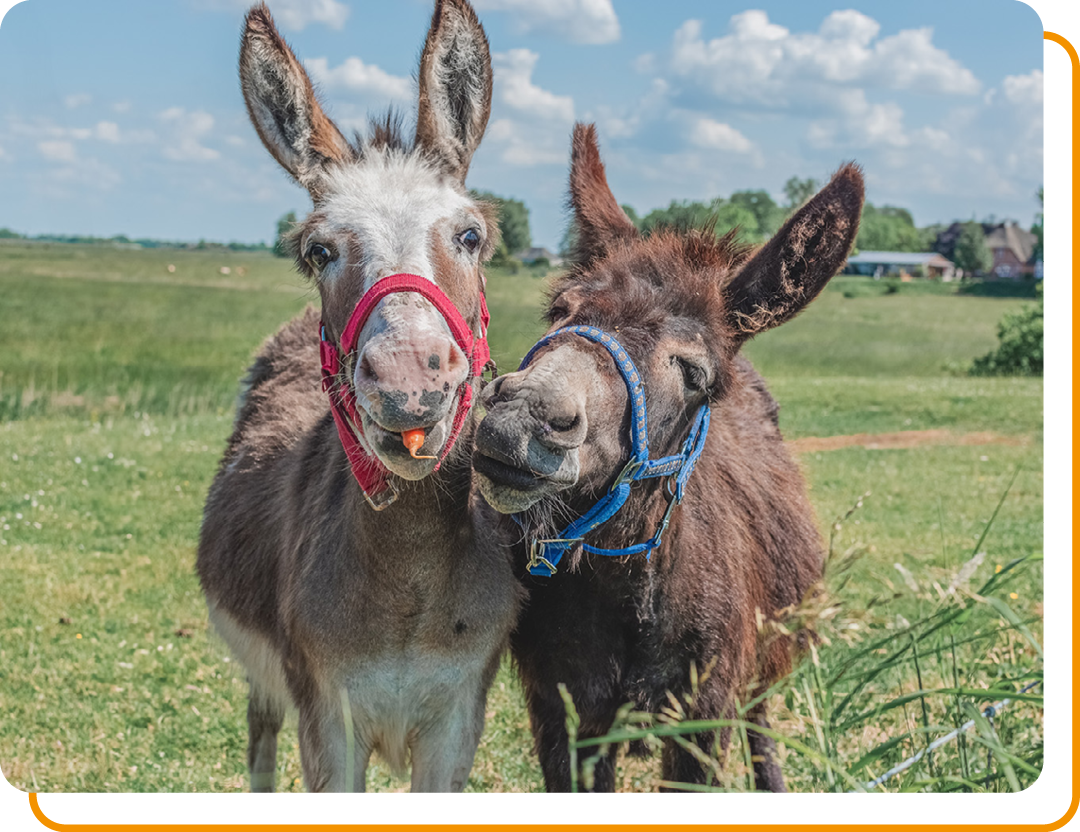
0,237,1047,792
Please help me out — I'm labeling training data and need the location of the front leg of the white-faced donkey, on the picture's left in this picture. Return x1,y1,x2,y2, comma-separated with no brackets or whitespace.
299,708,372,793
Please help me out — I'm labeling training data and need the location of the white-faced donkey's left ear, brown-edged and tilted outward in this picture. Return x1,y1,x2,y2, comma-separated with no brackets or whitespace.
240,3,351,190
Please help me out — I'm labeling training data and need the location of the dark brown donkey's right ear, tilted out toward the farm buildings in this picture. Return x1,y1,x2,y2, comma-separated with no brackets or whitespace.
724,159,863,341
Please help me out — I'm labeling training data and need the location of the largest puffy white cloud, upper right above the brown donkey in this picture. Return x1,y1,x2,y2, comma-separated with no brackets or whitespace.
671,10,981,109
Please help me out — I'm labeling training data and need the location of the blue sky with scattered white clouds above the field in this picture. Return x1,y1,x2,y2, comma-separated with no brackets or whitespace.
0,0,1080,249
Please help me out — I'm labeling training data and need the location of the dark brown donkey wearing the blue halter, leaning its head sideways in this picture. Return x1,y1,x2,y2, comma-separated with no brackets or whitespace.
473,125,863,791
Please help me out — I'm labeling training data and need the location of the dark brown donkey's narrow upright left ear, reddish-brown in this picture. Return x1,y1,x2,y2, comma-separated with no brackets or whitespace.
570,123,637,264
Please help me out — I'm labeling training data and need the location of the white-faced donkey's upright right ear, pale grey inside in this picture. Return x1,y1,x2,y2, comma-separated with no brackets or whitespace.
416,0,491,185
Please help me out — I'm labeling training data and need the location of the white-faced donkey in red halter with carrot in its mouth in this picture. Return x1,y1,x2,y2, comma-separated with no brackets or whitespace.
198,0,521,791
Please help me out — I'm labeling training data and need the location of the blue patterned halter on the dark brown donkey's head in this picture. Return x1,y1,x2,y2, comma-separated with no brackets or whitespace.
511,326,708,577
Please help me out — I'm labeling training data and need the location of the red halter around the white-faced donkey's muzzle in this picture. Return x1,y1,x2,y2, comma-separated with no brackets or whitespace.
319,274,491,511
